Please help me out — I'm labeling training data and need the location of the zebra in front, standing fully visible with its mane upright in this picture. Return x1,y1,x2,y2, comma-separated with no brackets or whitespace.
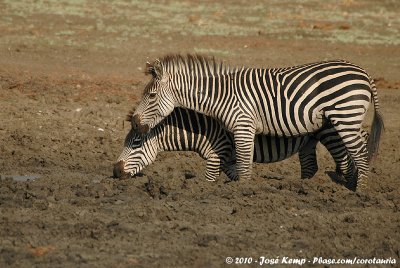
132,55,383,191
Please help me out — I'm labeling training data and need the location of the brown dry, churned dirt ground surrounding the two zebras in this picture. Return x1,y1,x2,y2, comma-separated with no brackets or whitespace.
0,0,400,267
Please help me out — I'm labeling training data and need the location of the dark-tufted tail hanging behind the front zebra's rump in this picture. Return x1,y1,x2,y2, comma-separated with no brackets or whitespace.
367,78,385,161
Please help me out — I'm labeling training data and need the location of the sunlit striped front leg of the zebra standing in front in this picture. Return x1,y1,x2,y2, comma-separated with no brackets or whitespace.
233,126,255,179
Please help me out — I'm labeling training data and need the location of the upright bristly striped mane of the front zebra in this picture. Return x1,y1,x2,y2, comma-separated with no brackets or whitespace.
146,54,238,76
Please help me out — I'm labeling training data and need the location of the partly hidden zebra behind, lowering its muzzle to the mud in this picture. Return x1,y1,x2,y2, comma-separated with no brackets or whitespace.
114,108,365,185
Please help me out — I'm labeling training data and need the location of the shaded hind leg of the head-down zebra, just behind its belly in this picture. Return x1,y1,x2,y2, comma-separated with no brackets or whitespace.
299,138,318,179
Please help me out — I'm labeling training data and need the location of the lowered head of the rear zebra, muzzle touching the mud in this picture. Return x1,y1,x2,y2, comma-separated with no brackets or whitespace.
113,114,158,179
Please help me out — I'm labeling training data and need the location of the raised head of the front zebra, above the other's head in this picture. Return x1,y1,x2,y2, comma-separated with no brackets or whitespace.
131,60,175,134
